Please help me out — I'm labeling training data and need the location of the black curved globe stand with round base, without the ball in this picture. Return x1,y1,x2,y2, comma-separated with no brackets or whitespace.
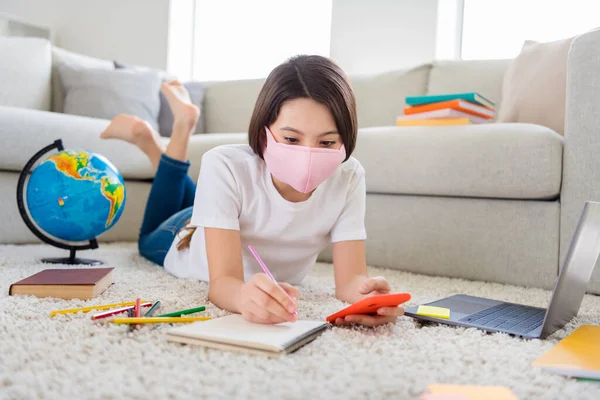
17,139,103,265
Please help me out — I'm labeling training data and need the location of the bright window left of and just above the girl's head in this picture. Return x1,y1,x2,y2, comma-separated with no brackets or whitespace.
192,0,332,81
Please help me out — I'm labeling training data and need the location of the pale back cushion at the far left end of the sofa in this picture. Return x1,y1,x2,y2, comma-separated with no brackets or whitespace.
0,36,52,111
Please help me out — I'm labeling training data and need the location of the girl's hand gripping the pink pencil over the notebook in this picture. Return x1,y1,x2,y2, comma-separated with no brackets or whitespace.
240,273,300,324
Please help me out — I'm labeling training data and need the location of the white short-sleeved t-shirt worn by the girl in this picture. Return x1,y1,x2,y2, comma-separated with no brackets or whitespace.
164,145,366,284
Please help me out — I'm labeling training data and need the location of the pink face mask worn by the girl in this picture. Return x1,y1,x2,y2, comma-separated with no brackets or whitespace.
263,127,346,193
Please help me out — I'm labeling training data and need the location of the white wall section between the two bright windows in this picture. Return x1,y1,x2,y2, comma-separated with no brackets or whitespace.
331,0,444,75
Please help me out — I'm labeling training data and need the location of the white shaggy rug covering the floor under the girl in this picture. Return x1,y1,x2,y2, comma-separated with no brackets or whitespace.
0,243,600,400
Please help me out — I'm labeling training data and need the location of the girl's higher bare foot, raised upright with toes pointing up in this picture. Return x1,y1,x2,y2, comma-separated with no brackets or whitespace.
161,81,200,161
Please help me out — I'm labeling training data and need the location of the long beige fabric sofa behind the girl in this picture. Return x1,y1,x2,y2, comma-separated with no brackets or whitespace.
0,32,600,293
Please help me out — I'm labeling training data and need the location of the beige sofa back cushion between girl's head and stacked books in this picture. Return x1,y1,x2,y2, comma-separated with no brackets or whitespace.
350,64,431,128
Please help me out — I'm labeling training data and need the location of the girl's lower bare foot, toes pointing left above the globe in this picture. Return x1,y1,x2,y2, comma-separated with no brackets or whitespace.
100,114,164,167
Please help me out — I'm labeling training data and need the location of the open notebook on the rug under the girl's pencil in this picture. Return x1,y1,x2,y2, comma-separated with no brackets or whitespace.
167,314,329,357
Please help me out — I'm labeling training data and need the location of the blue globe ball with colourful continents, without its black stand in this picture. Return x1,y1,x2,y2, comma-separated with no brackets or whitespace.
25,146,125,242
